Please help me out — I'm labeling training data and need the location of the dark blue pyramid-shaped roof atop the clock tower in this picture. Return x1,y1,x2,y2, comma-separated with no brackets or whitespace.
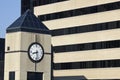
7,10,50,34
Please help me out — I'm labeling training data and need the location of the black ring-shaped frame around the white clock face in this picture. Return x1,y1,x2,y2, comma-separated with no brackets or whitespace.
28,42,44,63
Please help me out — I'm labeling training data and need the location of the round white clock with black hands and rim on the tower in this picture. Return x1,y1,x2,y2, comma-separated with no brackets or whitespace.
28,43,44,62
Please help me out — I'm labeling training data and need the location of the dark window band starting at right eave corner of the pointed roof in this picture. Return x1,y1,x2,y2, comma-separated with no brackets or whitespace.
51,21,120,36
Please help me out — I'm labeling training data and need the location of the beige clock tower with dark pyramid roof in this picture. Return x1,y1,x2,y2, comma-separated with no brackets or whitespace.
4,10,52,80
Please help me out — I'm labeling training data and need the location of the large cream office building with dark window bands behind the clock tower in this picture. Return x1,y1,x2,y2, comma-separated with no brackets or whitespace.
21,0,120,80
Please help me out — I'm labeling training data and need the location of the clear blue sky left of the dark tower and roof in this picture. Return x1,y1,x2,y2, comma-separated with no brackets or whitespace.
0,0,21,38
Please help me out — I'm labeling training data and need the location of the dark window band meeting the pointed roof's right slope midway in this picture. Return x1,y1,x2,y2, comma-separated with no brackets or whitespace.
38,1,120,21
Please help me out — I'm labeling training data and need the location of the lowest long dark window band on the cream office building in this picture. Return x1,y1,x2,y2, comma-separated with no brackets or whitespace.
54,59,120,70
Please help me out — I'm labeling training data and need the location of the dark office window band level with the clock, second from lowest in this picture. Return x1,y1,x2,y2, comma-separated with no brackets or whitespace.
53,40,120,53
